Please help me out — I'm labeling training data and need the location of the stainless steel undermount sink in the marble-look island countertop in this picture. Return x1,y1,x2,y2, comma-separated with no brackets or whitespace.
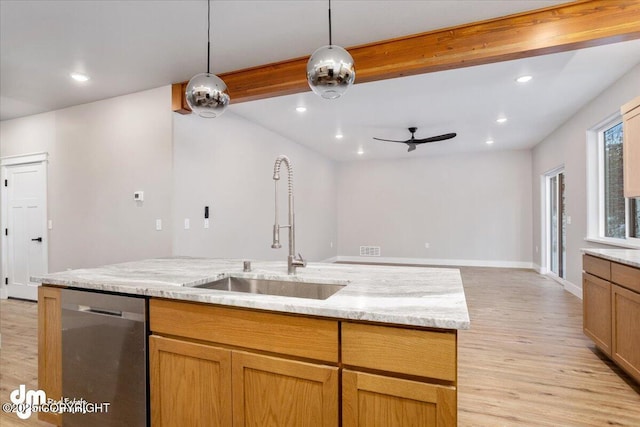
193,277,346,299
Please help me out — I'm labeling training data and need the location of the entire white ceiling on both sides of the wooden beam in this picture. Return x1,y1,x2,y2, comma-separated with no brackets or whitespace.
0,0,640,160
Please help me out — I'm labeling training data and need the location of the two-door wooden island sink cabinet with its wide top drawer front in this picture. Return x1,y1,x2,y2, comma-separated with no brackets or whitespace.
149,299,340,427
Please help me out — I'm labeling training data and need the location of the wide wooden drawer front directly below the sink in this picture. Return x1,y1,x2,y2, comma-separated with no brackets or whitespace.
149,298,338,363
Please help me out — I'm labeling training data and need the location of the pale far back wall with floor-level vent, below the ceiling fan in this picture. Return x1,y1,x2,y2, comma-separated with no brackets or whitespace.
338,150,531,267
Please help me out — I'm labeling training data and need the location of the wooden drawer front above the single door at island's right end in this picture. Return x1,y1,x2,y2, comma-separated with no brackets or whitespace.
342,322,457,382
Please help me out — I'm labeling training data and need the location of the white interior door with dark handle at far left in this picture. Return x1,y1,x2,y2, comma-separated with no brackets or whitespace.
3,162,48,300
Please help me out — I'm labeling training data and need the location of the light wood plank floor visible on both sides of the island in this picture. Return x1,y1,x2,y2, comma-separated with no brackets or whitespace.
0,268,640,427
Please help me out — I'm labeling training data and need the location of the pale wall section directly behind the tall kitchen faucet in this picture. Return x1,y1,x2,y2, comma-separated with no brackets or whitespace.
173,109,337,261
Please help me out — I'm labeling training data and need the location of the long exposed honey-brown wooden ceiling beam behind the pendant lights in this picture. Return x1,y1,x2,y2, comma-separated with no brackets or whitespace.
172,0,640,114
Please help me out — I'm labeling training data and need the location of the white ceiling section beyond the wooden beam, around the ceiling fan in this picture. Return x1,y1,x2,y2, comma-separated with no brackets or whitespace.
232,40,640,161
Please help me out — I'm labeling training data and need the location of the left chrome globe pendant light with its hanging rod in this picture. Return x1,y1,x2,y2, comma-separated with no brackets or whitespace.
185,0,231,119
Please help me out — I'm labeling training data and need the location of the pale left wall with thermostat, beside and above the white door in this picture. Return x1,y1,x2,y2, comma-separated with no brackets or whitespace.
0,86,172,280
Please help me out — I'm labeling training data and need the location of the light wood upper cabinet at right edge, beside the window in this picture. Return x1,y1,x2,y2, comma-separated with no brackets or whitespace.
620,96,640,197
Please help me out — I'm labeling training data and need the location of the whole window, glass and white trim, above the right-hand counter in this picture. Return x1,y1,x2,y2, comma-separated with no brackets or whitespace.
589,115,640,246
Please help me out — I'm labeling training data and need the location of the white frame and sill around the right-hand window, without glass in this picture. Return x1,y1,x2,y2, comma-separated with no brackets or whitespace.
585,112,640,249
